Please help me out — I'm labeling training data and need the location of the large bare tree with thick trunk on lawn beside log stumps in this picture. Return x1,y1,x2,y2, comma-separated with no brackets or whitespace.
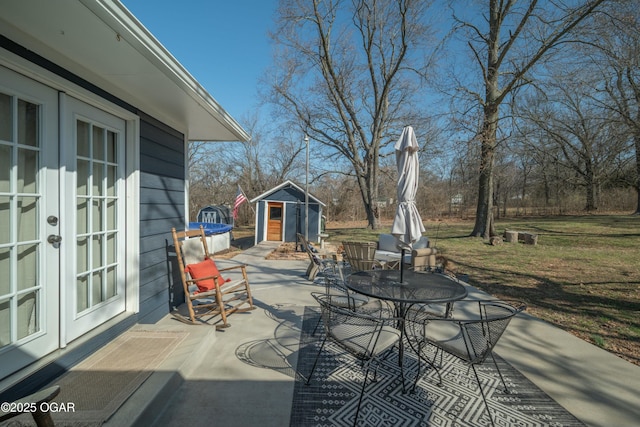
452,0,606,238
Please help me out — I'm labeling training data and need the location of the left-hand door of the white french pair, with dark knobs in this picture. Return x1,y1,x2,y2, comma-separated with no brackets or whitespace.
0,66,61,378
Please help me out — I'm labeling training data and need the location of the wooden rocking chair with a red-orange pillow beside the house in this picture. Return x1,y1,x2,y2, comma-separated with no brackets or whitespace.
171,226,256,328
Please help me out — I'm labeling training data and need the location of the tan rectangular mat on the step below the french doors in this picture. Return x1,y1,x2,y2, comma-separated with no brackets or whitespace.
5,331,188,426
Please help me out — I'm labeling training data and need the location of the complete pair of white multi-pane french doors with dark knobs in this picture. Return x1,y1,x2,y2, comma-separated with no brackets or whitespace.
0,65,126,379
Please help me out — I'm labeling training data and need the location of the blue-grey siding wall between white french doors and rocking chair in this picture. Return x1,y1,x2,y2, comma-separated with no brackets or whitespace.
140,114,186,315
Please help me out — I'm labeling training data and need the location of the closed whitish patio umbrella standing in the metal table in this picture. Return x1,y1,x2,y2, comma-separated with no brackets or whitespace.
391,126,424,281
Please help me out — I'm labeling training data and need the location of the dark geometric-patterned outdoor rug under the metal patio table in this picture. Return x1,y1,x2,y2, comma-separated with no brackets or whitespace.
291,307,584,427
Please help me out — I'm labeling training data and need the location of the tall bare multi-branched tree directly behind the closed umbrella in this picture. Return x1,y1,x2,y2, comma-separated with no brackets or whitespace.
269,0,440,229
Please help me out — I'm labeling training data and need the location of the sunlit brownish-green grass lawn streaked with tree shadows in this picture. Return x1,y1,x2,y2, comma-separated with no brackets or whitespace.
327,215,640,365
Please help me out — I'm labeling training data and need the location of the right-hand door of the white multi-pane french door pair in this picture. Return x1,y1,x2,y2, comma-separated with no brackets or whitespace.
61,97,126,342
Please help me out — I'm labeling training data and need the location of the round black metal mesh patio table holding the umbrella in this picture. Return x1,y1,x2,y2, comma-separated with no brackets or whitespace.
345,270,467,391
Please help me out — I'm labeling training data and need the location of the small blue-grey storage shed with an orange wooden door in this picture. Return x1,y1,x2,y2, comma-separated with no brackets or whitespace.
251,181,325,244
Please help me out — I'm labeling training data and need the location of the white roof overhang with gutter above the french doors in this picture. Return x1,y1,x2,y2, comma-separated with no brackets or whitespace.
0,0,251,141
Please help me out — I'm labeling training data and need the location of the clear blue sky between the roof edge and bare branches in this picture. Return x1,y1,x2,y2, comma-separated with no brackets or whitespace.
120,0,278,123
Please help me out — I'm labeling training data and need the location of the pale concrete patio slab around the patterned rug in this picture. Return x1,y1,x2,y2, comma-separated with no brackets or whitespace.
5,243,640,427
